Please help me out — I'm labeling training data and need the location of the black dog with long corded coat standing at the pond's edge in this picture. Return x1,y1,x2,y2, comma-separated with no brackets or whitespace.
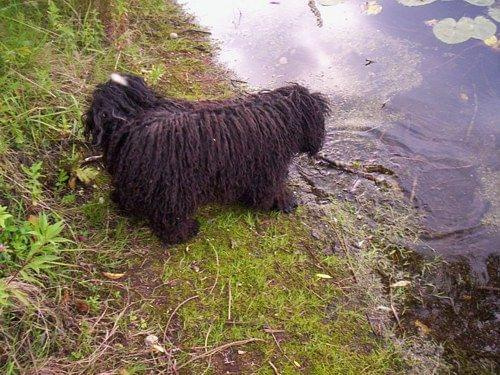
85,73,328,243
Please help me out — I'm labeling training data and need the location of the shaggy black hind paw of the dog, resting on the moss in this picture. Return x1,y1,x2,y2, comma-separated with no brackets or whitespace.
150,218,200,245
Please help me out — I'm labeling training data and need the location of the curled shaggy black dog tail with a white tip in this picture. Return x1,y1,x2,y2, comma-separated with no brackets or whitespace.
84,73,159,149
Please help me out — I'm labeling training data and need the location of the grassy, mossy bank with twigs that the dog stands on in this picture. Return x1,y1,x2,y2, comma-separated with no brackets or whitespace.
0,0,444,374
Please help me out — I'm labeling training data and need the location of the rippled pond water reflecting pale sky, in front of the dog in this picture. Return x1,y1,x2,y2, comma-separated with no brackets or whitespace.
184,0,500,282
